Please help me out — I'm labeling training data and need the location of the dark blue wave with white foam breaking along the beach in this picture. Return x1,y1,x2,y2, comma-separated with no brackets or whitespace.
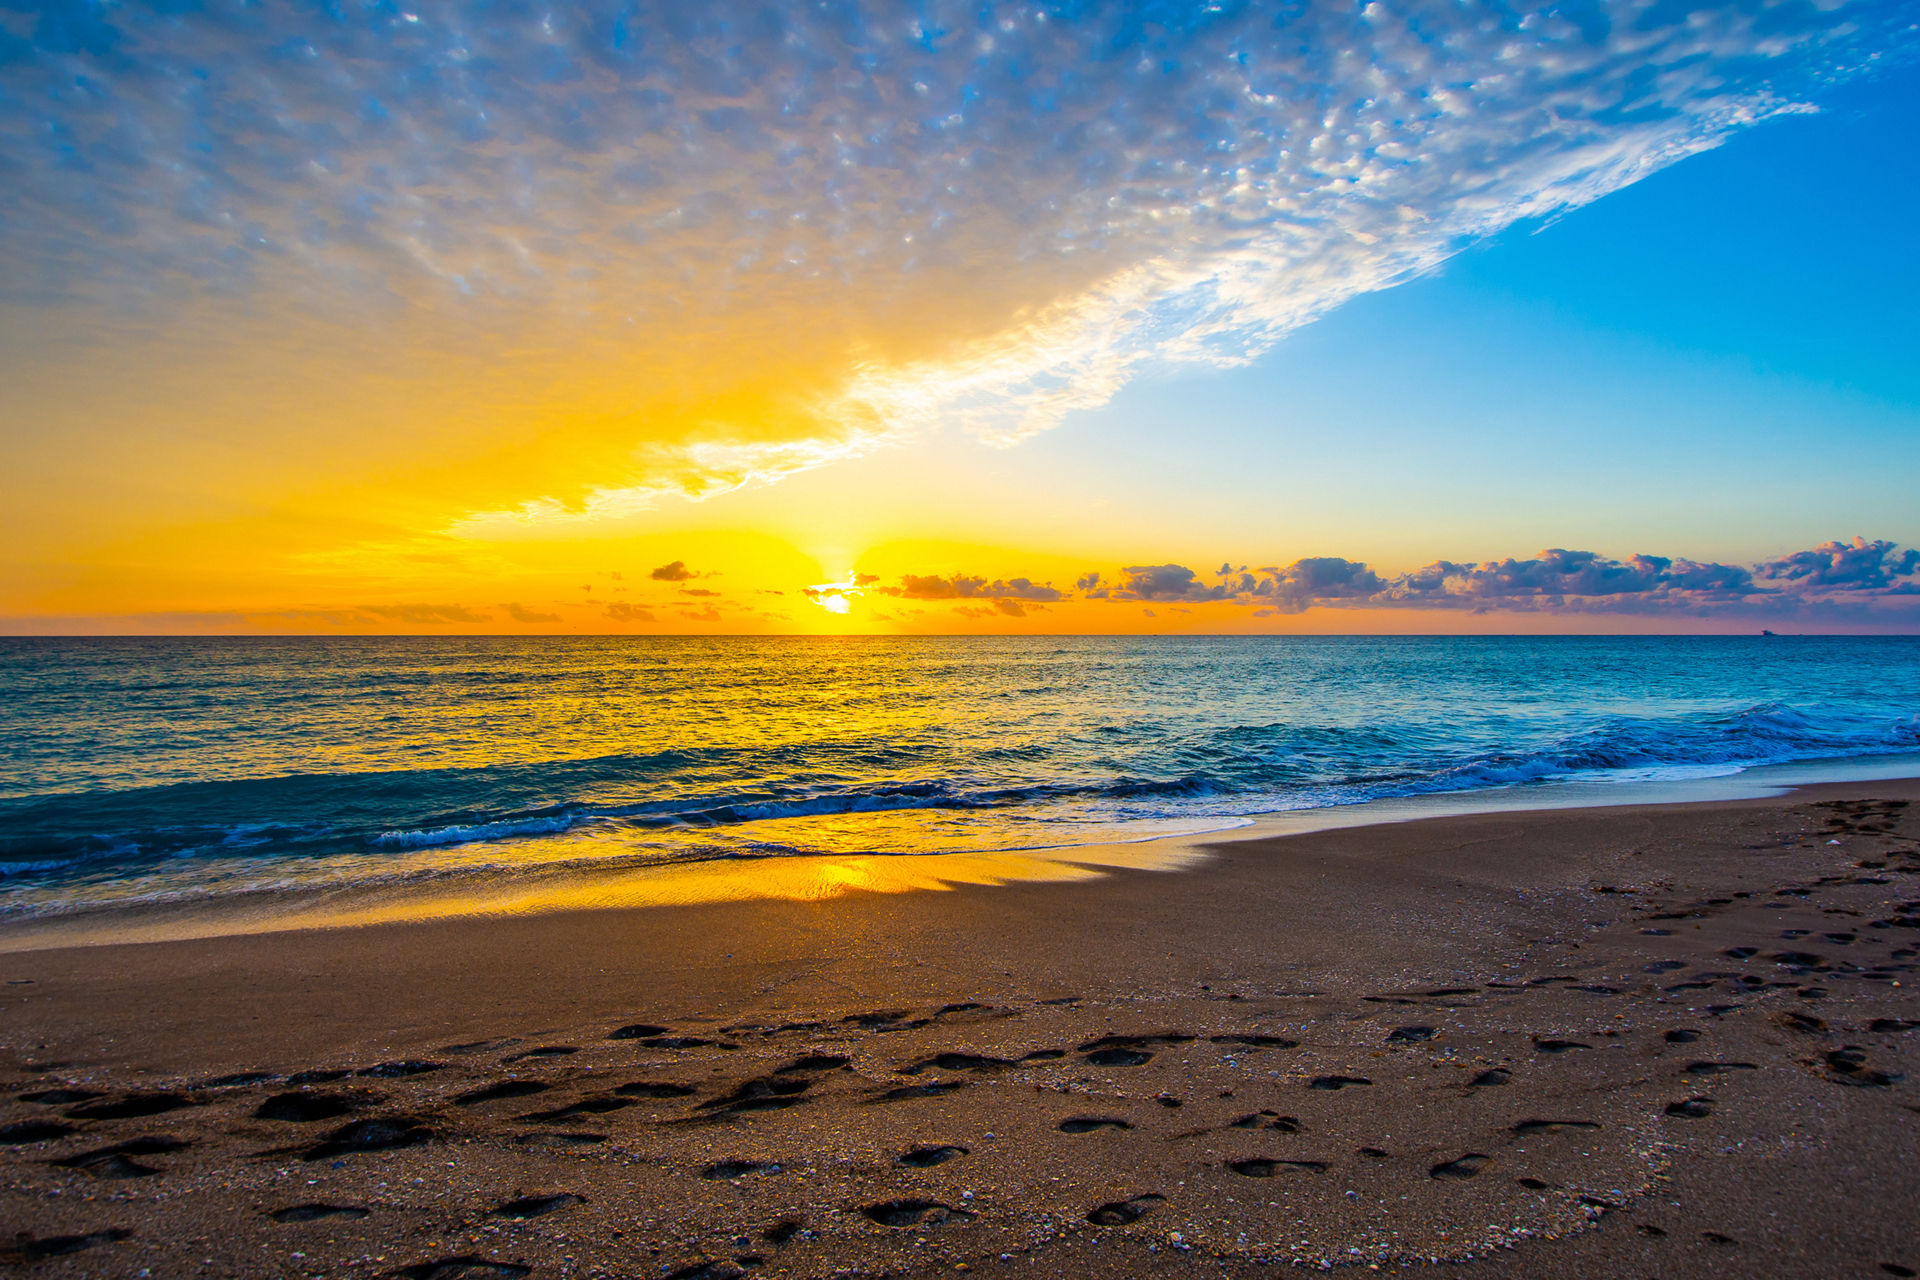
0,702,1920,875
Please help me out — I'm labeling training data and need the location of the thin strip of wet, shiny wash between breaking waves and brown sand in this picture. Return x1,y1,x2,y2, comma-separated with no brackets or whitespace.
0,754,1920,956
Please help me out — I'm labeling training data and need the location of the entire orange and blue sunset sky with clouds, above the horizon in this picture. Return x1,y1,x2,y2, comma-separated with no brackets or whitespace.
0,0,1920,635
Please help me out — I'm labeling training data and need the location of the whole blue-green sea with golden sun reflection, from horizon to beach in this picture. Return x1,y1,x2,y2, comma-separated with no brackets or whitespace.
0,637,1920,919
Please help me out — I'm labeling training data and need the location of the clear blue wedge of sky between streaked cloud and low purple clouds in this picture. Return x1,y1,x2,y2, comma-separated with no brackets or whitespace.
1033,48,1920,560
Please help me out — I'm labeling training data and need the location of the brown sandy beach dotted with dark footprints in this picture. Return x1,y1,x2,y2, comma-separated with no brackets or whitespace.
0,781,1920,1280
